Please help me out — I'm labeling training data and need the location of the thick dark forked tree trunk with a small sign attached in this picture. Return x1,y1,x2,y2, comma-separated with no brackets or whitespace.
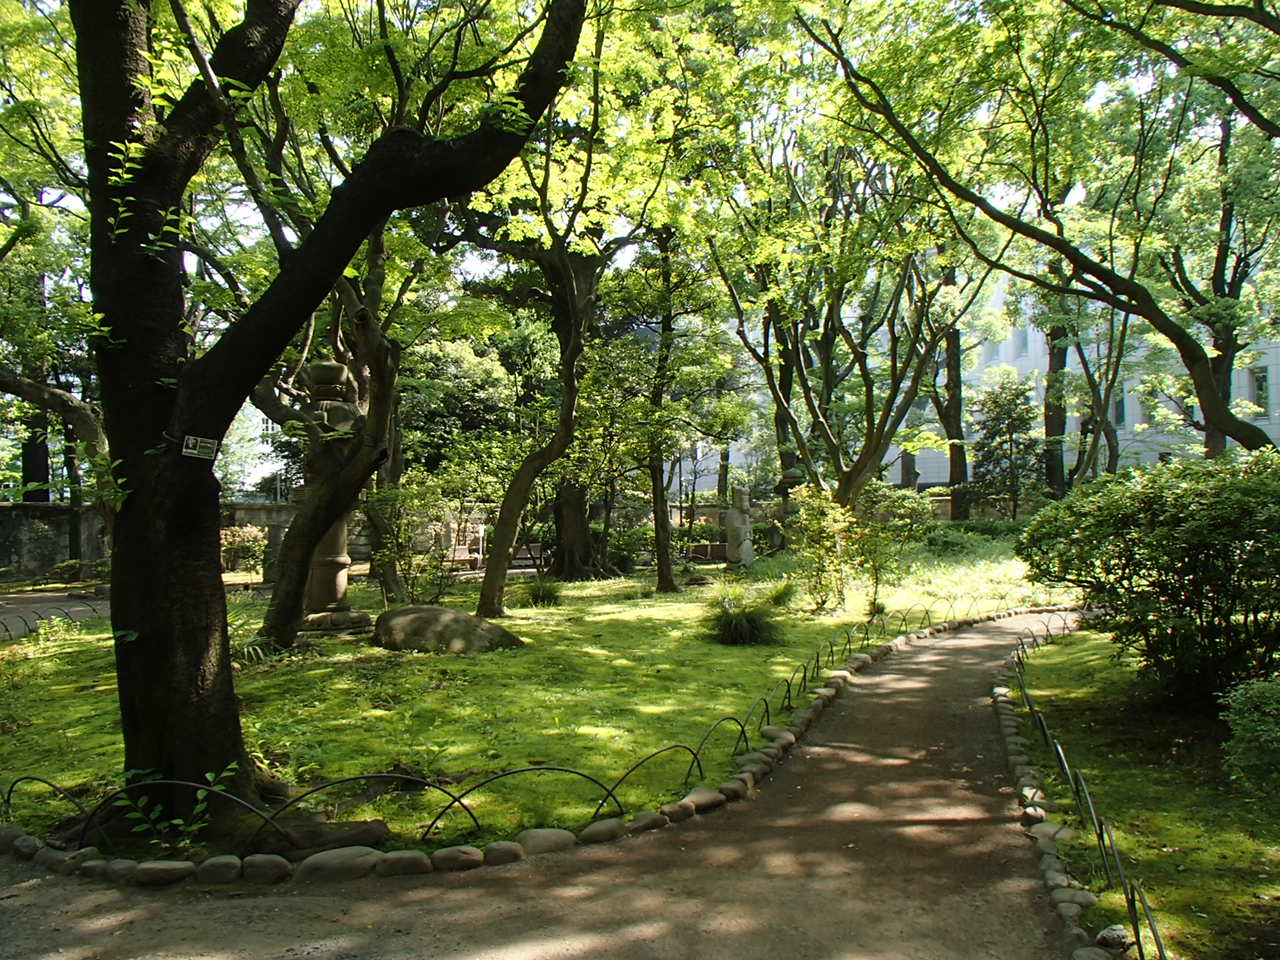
70,0,582,798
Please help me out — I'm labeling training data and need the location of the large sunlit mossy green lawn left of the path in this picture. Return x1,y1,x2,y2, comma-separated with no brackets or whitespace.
0,553,1055,846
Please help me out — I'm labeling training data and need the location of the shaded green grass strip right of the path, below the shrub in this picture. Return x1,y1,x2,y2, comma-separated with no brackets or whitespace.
1027,631,1280,960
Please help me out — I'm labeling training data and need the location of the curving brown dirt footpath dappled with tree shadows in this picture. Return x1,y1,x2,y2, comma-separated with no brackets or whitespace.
0,616,1059,960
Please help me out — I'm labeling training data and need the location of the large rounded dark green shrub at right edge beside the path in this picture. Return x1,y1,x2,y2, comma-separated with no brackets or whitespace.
1018,451,1280,698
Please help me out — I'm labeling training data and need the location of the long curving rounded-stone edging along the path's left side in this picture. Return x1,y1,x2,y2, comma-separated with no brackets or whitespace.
0,605,1088,901
